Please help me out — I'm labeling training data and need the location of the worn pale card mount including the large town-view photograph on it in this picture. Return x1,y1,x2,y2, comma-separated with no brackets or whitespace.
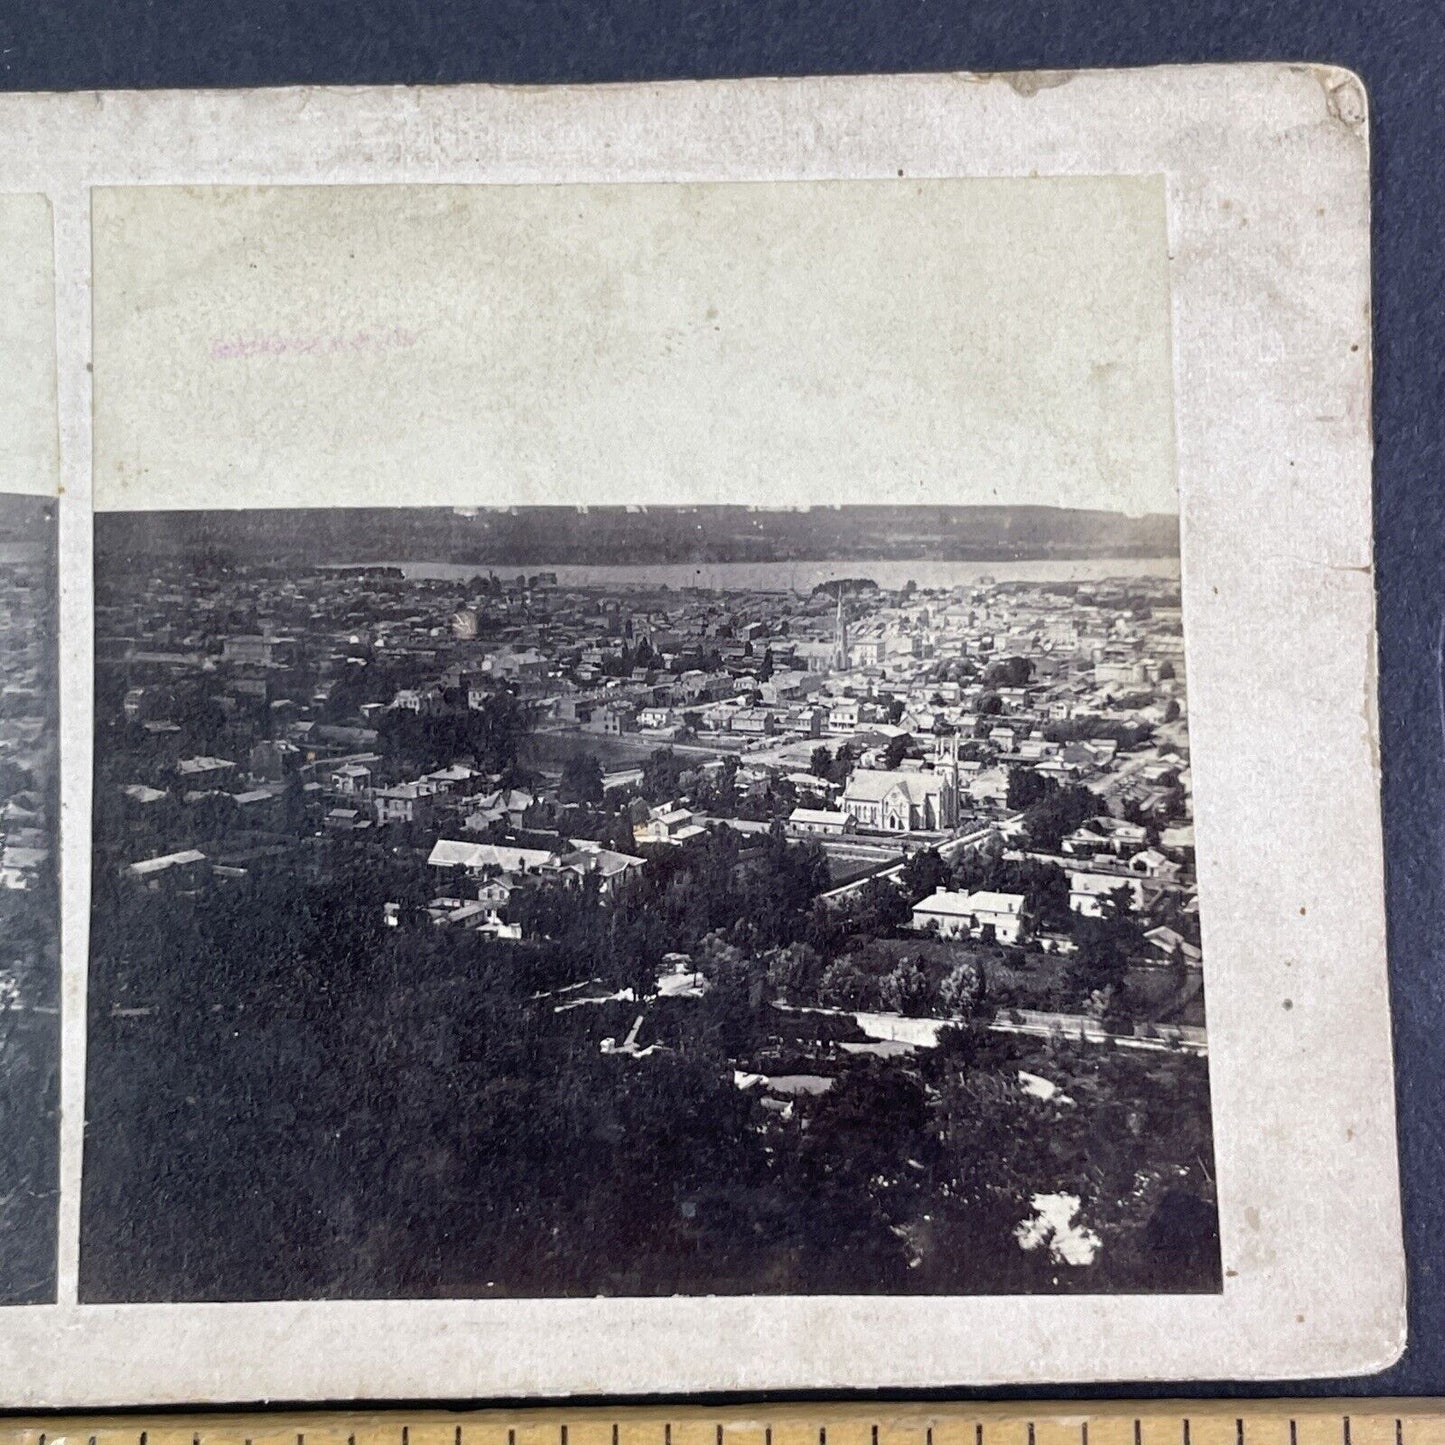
0,66,1403,1405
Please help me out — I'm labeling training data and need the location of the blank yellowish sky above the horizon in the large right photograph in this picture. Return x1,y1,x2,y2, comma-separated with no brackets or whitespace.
92,176,1178,514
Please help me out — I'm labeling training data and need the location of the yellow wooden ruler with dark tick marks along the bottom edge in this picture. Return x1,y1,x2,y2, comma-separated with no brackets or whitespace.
0,1400,1445,1445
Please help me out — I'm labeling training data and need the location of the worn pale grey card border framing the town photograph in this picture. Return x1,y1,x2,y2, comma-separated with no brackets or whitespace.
0,65,1405,1406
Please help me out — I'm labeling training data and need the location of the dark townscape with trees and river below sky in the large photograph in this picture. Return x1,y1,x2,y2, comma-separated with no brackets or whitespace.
81,506,1220,1301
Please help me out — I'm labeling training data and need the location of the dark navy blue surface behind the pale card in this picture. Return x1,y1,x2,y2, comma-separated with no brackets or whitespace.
0,0,1445,1397
